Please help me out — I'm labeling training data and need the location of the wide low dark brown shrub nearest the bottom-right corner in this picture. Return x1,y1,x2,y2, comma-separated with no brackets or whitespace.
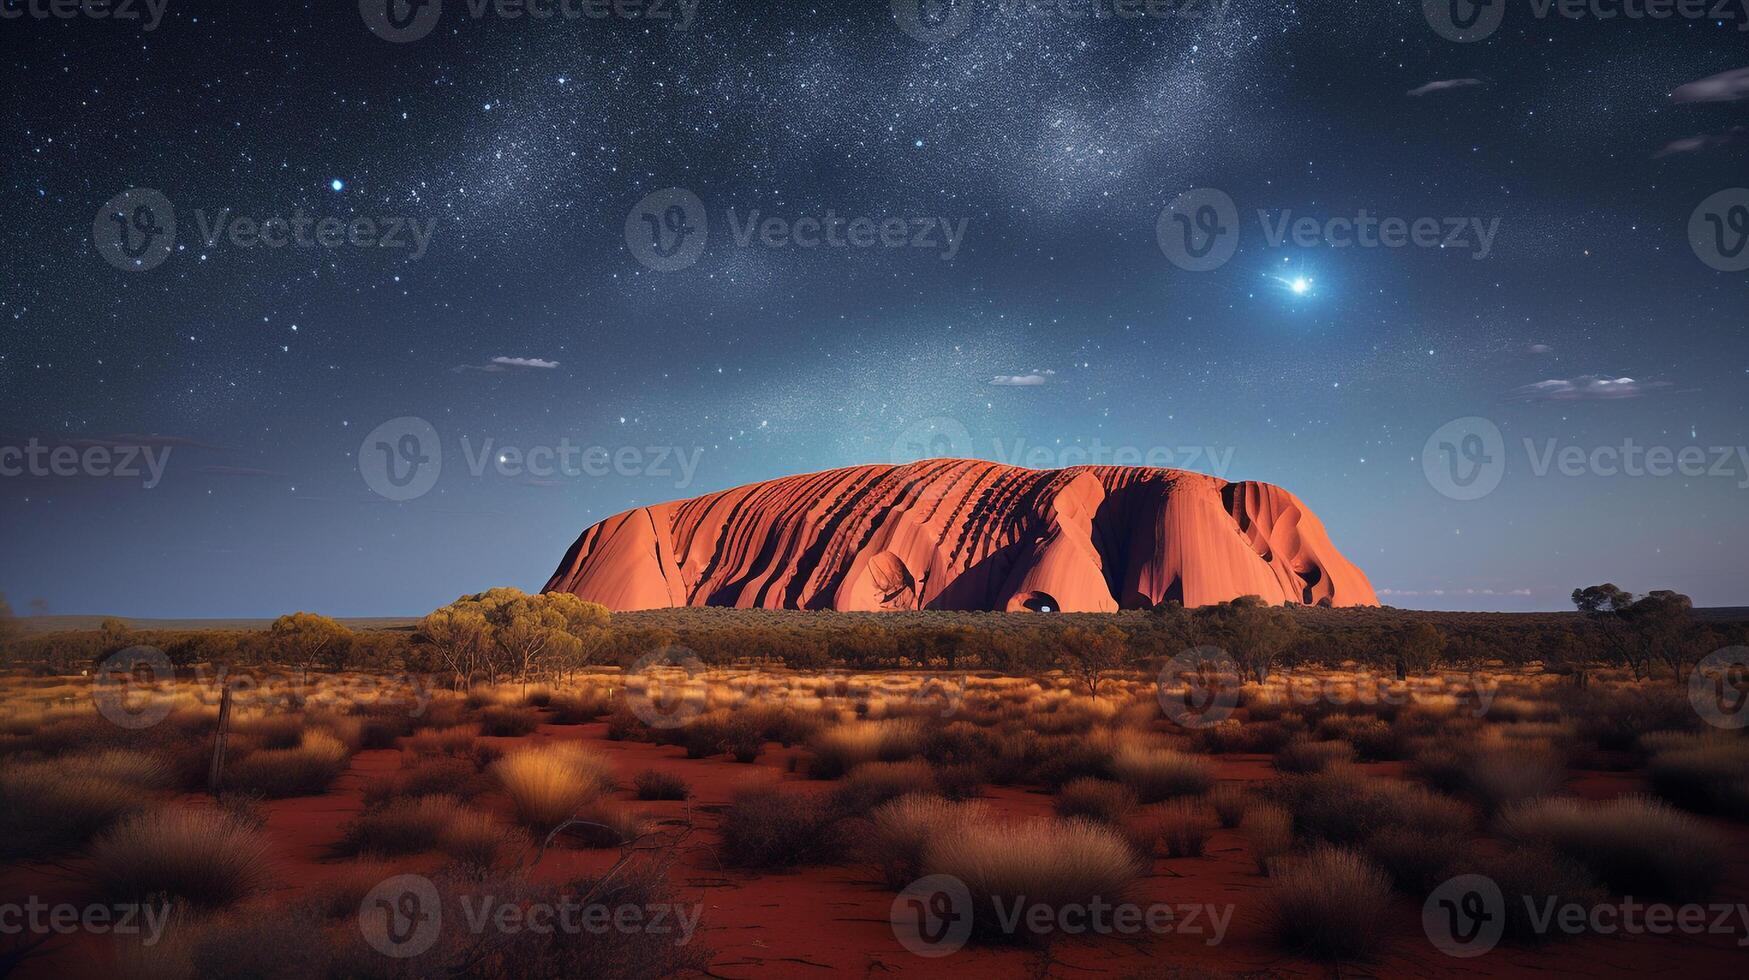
1501,796,1726,901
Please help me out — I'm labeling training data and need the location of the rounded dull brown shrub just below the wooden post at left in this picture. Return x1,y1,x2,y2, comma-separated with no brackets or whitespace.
87,807,268,908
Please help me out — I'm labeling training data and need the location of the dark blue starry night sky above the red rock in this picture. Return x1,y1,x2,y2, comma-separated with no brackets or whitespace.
0,0,1749,618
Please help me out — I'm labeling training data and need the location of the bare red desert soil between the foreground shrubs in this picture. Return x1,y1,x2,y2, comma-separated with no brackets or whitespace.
0,723,1749,980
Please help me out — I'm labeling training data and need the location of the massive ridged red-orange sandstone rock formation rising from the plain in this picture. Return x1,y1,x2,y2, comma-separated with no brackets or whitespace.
546,459,1378,613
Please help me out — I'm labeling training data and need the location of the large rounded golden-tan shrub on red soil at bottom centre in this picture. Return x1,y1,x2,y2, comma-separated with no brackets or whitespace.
922,819,1144,942
